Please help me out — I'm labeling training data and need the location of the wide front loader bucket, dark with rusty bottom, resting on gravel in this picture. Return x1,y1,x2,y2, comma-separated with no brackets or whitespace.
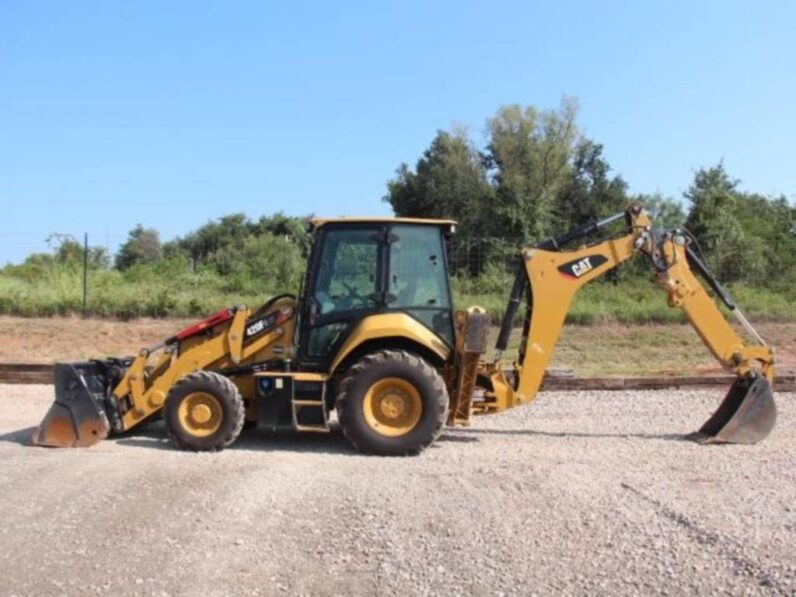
32,363,111,448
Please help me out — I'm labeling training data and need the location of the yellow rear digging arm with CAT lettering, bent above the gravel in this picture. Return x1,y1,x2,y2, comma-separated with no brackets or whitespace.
473,204,776,443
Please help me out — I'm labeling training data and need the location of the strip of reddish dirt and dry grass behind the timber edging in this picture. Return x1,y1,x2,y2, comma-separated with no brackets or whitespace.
0,316,796,377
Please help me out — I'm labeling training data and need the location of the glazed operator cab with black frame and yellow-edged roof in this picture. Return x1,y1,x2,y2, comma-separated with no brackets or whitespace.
298,218,455,369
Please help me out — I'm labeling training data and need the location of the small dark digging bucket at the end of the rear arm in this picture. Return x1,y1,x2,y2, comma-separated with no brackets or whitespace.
694,375,777,444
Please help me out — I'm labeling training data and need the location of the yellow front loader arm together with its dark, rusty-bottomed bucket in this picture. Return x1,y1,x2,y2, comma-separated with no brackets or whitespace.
32,295,295,447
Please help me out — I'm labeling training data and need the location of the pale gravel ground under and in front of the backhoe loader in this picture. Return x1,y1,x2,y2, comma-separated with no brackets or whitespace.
0,385,796,597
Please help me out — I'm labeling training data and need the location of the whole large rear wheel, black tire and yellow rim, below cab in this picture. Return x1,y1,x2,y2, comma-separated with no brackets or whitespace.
336,350,448,456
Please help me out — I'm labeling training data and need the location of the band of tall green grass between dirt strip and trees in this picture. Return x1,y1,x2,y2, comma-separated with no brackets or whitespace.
0,267,796,324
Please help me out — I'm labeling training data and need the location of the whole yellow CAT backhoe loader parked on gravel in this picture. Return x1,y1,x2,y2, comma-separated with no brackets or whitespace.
33,204,776,455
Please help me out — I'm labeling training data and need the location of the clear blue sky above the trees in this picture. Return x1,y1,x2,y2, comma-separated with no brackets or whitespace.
0,0,796,264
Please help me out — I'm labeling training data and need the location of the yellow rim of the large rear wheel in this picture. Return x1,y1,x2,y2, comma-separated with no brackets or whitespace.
362,377,423,437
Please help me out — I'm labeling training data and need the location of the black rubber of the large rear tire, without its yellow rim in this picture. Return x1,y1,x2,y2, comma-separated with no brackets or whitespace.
335,350,448,456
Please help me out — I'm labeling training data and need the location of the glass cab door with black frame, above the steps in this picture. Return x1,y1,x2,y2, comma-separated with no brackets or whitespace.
299,224,386,370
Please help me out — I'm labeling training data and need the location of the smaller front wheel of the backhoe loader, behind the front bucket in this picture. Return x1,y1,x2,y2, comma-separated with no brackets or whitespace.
163,371,246,452
